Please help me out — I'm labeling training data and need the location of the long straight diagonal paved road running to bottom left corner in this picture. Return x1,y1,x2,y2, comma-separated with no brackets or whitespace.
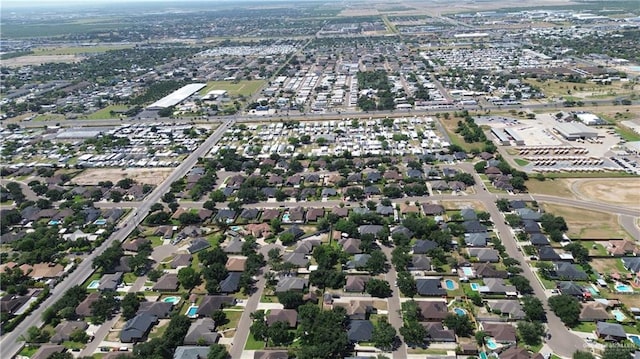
0,121,233,358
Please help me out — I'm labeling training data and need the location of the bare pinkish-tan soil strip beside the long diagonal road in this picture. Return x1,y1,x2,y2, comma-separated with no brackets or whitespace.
72,168,174,186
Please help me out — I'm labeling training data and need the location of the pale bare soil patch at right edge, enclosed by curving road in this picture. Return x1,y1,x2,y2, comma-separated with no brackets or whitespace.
575,178,640,206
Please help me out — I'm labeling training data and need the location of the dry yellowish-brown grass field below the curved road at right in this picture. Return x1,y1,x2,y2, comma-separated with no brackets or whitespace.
543,203,630,239
